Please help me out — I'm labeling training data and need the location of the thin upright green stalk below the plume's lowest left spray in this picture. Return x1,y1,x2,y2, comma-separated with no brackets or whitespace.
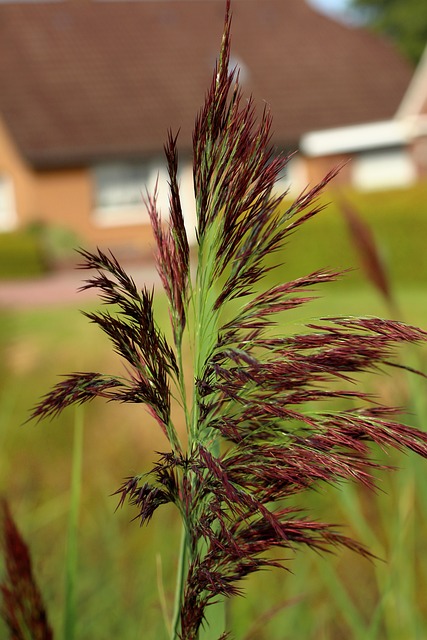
63,406,84,640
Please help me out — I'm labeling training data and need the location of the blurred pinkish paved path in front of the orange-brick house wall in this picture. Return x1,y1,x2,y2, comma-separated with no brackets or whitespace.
0,264,159,309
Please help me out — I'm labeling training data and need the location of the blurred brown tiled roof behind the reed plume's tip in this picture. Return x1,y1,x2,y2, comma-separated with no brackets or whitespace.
0,0,411,167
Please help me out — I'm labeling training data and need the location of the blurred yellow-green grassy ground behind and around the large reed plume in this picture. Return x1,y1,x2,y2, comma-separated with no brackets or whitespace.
0,182,427,640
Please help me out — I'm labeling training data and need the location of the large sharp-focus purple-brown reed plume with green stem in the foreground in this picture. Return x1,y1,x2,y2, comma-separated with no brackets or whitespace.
28,3,427,640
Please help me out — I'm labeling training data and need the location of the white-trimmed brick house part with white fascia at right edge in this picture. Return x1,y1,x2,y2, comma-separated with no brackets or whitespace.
300,47,427,190
